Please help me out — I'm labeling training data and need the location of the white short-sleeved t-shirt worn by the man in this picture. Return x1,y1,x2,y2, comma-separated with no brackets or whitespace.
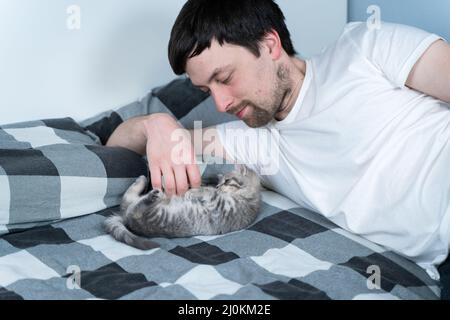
217,22,450,279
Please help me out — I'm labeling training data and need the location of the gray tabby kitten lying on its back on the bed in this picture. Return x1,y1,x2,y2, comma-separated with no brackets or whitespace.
104,165,261,250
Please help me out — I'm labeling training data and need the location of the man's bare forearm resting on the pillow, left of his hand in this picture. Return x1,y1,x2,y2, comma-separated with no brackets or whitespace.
106,115,150,156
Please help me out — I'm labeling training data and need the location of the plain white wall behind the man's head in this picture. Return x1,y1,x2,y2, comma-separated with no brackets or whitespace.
0,0,347,124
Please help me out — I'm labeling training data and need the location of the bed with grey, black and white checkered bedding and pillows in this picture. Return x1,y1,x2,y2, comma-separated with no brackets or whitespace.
0,78,441,300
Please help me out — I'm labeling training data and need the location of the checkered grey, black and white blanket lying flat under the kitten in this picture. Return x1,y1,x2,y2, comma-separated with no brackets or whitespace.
0,191,439,300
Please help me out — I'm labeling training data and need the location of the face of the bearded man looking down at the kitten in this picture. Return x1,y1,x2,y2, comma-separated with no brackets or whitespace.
186,41,291,128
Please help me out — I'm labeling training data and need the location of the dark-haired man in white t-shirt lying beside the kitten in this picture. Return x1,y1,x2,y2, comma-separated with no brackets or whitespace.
107,0,450,278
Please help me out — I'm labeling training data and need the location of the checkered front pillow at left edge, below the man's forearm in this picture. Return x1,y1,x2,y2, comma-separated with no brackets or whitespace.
0,118,147,233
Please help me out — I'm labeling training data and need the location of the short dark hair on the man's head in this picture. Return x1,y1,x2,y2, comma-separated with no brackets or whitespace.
169,0,297,75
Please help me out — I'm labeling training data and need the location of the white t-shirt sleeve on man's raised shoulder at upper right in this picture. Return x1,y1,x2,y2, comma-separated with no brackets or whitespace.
344,22,443,88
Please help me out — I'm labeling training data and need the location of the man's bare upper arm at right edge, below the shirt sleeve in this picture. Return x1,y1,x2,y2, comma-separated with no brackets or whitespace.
406,40,450,103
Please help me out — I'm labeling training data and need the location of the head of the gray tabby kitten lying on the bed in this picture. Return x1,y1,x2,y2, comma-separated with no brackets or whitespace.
217,165,261,196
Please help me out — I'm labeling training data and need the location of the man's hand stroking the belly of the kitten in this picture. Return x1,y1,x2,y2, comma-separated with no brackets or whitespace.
144,114,201,196
